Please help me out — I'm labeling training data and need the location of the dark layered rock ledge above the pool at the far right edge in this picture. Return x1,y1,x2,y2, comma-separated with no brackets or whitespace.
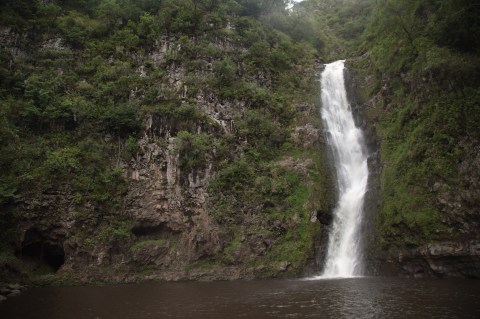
387,143,480,278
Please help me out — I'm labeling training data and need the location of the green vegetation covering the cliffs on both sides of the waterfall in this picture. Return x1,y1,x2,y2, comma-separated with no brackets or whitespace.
0,0,480,282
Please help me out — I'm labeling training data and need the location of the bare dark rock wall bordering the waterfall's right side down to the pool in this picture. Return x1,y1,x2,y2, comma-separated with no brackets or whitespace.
347,54,480,278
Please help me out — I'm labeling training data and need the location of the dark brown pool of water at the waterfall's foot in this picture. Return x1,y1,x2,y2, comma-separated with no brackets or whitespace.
0,278,480,319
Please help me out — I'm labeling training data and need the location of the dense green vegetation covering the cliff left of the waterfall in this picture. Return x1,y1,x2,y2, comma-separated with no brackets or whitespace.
0,0,338,282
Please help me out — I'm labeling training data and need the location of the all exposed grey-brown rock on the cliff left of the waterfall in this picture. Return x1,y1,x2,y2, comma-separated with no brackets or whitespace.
2,26,331,283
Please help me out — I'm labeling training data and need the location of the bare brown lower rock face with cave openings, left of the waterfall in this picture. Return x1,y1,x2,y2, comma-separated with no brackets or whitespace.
16,131,327,282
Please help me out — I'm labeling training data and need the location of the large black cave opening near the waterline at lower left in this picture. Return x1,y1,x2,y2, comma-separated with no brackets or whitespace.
20,229,65,271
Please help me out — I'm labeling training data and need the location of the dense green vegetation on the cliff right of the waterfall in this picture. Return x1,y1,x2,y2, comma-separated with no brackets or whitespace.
352,0,480,249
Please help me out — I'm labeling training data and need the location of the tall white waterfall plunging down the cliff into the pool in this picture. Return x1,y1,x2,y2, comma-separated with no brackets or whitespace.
317,60,368,278
